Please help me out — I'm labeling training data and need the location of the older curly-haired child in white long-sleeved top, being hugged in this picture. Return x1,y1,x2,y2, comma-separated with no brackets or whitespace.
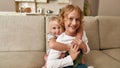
47,5,90,68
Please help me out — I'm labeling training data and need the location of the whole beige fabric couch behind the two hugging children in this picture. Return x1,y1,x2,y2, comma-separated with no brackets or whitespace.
0,16,120,68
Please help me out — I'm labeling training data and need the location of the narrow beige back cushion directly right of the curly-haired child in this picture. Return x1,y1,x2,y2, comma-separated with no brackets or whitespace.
83,16,99,49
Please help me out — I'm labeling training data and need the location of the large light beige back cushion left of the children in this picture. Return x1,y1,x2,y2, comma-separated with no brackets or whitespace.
0,16,45,51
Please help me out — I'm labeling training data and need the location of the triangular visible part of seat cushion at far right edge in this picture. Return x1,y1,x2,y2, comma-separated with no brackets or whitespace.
103,48,120,62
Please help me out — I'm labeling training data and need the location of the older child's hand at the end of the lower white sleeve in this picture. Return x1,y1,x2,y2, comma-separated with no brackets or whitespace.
69,45,80,61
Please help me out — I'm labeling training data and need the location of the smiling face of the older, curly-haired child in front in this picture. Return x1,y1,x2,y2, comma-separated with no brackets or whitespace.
64,10,80,36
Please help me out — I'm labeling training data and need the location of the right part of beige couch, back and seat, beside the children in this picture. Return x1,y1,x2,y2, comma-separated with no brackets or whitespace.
84,16,120,68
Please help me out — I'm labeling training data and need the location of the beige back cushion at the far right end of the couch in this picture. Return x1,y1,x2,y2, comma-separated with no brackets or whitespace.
96,16,120,49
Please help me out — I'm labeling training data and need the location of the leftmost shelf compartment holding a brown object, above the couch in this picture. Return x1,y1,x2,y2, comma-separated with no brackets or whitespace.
15,0,37,13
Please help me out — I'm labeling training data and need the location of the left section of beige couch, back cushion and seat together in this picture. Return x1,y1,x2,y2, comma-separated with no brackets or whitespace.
0,15,45,68
